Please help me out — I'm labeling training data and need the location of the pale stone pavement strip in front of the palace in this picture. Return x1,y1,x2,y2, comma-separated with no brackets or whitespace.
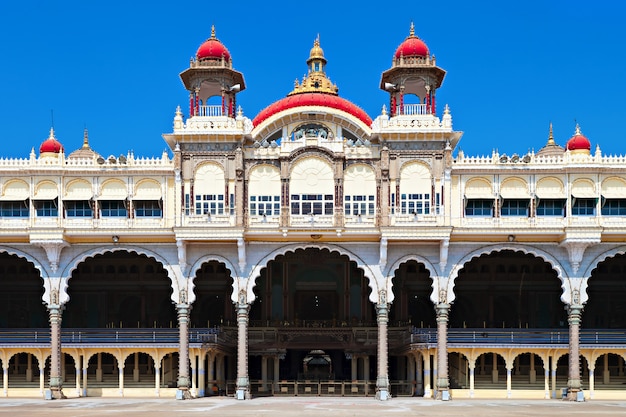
0,397,626,417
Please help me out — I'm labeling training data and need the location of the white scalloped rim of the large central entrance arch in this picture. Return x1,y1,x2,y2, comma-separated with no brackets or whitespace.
246,242,378,303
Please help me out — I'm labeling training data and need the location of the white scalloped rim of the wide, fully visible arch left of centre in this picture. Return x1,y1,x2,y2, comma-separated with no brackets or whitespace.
59,245,182,304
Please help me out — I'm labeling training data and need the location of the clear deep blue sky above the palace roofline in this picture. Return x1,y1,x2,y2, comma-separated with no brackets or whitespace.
0,0,626,157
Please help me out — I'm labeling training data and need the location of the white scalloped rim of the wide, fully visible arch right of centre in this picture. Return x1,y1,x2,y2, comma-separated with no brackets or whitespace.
447,244,570,303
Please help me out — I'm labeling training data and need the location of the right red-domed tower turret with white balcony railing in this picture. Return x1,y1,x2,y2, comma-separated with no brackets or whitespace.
380,23,446,117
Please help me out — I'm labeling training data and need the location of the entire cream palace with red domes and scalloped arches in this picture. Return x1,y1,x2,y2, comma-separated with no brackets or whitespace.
0,25,626,401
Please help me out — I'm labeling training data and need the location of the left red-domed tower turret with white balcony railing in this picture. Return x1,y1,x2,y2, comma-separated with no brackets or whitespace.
180,26,246,118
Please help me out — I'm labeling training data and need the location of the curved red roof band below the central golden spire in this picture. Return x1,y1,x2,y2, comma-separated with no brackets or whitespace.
252,93,372,127
